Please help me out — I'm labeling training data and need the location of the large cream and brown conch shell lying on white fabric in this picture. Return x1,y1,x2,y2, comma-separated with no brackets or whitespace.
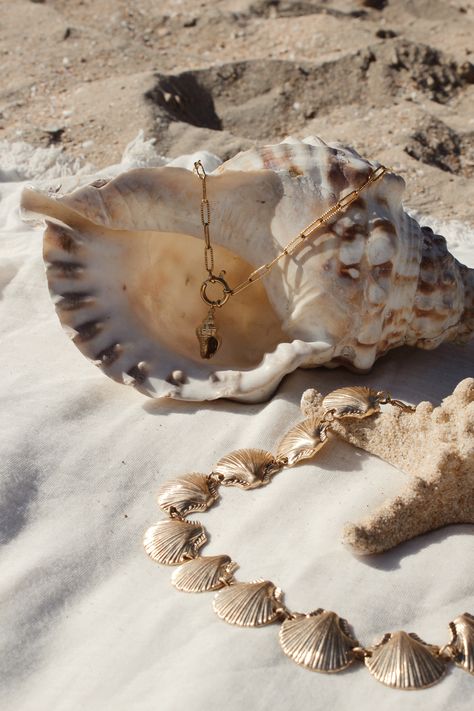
22,137,474,402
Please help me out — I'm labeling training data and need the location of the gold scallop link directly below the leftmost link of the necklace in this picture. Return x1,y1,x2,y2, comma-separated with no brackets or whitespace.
171,555,237,592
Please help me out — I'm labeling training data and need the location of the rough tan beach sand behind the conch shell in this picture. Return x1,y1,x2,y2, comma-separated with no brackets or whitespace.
0,0,474,223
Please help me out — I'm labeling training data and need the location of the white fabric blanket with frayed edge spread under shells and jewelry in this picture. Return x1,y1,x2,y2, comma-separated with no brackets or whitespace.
0,135,474,711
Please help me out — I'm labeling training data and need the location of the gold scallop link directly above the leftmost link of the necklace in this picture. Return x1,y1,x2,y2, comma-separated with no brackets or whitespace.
158,473,219,516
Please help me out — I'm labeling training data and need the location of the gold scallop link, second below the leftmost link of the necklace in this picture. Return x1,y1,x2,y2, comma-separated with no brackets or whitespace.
213,580,281,627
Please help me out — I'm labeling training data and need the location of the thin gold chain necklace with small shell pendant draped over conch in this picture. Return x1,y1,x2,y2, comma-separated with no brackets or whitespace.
194,160,387,358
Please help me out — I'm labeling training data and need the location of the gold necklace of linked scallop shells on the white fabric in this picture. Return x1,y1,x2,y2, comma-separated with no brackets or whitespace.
143,387,474,689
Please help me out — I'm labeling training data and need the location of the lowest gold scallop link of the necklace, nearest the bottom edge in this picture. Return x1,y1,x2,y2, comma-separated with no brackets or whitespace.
365,632,446,689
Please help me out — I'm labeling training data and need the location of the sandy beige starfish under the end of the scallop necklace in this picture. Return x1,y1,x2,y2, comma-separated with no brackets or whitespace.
301,378,474,555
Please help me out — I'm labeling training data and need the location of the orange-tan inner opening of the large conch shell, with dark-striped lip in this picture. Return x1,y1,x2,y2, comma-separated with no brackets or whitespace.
45,223,288,383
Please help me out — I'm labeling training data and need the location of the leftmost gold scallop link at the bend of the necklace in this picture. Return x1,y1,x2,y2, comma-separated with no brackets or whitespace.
143,519,207,565
